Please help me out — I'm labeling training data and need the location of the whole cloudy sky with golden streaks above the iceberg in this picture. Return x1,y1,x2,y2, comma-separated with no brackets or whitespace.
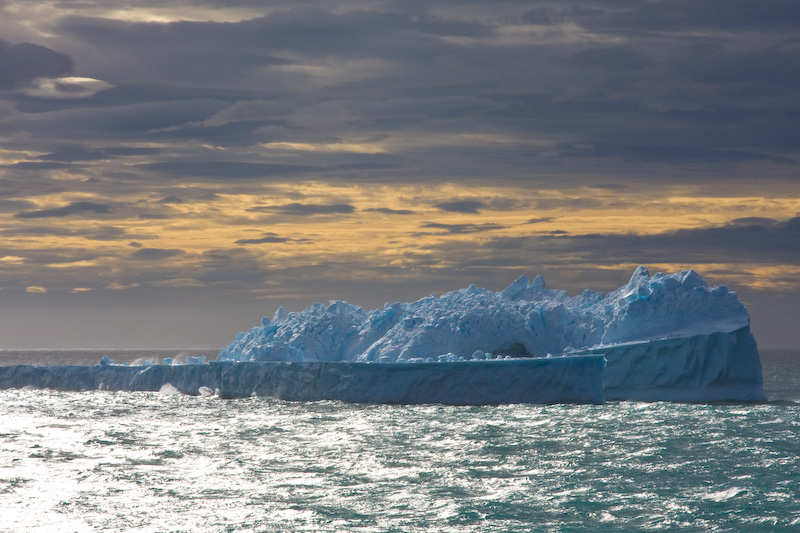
0,0,800,349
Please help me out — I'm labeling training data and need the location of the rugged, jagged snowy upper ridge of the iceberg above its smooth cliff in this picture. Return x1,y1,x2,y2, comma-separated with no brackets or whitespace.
218,267,749,362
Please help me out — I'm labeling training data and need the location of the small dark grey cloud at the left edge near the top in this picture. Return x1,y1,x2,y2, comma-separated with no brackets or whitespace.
0,40,72,90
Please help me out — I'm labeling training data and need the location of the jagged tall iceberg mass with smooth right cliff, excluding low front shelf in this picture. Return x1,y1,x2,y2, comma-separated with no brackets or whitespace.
218,266,766,402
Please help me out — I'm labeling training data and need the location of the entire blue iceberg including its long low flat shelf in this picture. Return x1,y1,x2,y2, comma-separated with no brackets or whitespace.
0,267,766,404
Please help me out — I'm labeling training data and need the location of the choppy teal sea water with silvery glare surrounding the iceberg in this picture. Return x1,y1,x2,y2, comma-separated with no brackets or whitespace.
0,352,800,533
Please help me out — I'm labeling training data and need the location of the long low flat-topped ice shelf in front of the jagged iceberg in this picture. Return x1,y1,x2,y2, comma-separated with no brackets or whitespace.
0,355,605,405
